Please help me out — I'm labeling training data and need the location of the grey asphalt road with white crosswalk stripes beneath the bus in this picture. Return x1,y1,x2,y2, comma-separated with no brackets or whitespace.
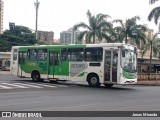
0,71,160,120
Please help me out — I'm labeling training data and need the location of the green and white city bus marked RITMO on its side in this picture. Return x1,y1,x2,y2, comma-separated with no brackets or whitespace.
10,43,137,87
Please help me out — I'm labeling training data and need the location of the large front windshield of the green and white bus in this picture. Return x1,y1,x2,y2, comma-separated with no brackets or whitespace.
121,48,137,73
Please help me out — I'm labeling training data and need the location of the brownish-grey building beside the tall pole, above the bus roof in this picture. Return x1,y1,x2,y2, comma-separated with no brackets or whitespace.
38,31,54,45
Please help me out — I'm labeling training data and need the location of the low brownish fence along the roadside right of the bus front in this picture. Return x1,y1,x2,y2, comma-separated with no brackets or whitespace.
138,73,160,80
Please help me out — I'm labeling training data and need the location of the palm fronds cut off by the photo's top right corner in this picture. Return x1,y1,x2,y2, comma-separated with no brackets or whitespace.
148,0,160,25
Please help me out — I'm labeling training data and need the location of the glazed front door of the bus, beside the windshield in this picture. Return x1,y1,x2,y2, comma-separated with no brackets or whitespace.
104,50,118,83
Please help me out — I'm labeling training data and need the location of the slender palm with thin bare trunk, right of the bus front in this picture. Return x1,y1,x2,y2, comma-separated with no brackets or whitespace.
142,33,160,79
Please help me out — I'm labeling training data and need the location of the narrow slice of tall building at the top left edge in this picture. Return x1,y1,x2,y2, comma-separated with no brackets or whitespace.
0,0,4,34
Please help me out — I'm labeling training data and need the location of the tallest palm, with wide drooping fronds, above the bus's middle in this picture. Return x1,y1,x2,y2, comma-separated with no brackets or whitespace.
73,10,112,43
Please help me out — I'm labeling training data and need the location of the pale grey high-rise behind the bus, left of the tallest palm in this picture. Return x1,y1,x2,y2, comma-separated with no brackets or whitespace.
60,28,81,44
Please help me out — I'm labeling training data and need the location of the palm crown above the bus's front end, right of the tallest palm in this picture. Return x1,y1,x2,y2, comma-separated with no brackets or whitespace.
112,16,147,45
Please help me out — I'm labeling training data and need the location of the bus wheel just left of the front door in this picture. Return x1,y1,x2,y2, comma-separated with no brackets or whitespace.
87,74,100,87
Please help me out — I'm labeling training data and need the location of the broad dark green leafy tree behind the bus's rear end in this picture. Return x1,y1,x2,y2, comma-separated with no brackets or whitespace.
0,26,37,51
